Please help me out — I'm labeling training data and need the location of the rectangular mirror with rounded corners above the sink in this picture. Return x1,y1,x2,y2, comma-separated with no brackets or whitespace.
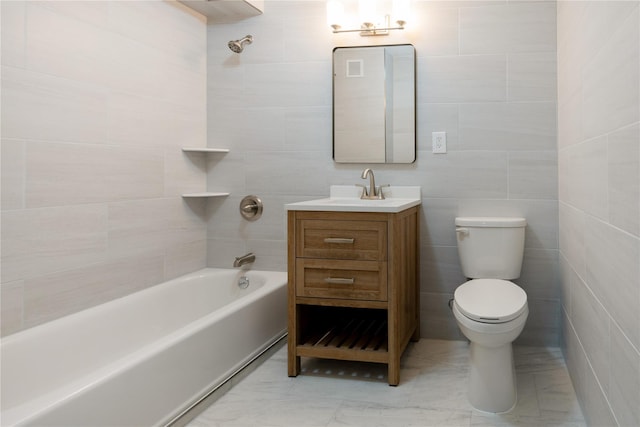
333,45,416,163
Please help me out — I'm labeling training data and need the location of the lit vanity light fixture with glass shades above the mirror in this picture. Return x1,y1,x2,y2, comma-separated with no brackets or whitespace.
327,0,410,36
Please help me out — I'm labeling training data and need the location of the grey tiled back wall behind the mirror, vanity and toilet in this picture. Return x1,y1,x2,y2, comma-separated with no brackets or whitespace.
207,0,560,345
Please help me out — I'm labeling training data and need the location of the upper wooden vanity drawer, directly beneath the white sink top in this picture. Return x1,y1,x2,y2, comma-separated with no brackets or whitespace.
296,219,387,261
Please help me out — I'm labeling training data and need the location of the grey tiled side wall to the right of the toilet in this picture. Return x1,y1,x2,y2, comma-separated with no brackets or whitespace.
558,1,640,426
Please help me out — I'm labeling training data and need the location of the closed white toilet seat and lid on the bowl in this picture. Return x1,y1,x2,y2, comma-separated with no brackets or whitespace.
453,279,527,323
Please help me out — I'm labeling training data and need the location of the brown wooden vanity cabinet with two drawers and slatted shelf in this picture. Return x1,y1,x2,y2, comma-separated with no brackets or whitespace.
288,206,420,385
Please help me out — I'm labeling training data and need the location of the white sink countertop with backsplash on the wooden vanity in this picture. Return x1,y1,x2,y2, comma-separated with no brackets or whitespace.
285,185,421,213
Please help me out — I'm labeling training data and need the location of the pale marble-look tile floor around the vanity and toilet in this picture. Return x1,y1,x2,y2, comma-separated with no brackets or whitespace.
188,340,586,427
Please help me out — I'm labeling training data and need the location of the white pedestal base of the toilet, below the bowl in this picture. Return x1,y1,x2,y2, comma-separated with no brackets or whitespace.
468,342,517,413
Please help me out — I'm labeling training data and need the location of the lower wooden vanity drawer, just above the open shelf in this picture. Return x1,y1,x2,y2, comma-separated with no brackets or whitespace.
296,258,387,301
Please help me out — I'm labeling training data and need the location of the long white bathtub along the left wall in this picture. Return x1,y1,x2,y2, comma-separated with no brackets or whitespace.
0,268,287,426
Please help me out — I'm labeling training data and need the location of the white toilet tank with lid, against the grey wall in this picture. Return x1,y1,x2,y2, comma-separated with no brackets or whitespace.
456,217,527,280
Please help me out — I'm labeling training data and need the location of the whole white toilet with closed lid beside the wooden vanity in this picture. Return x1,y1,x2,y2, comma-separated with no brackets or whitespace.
452,217,529,412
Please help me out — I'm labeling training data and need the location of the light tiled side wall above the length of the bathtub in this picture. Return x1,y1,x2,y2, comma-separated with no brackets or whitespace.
0,1,206,335
